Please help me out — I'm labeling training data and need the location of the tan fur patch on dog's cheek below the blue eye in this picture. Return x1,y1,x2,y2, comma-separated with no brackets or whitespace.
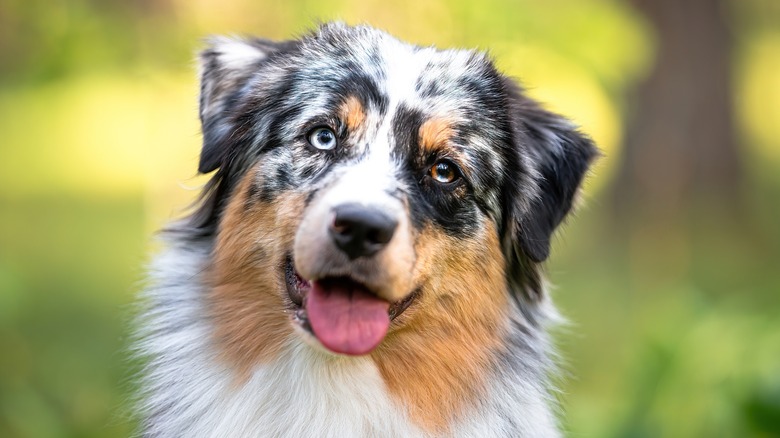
209,173,303,378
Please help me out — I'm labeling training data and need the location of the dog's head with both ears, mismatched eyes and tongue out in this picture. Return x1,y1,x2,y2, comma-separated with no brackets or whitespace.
192,24,596,357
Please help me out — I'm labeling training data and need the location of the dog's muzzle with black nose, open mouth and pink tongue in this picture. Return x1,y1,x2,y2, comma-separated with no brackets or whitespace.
287,185,416,355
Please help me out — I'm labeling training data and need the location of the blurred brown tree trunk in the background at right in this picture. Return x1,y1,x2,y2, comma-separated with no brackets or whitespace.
615,0,741,222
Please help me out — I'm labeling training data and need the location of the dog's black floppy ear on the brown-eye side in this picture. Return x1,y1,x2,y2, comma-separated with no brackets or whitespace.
504,79,598,293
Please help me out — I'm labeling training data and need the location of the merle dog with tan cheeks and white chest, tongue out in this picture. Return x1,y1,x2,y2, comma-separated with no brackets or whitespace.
137,23,598,437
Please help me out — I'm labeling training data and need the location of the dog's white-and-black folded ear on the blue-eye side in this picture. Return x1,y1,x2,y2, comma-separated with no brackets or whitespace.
198,37,291,173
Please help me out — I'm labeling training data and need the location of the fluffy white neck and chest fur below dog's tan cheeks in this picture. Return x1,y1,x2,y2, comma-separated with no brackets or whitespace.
137,236,559,437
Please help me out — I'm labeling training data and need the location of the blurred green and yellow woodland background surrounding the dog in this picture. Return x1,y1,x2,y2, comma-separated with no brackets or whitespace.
0,0,780,437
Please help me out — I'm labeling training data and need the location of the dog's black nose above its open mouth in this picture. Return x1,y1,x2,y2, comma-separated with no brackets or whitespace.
329,204,398,260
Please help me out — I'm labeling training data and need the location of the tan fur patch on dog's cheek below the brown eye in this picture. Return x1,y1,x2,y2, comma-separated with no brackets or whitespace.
374,224,509,434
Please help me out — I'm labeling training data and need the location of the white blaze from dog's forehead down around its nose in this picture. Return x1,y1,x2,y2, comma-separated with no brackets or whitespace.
294,39,427,302
